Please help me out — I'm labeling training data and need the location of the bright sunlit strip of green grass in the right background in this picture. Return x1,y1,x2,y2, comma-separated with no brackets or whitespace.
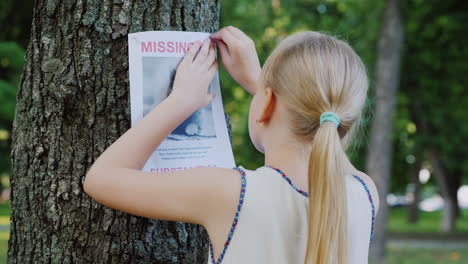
388,208,468,232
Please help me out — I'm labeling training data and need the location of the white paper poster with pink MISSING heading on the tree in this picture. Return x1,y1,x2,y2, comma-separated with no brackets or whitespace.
128,31,235,172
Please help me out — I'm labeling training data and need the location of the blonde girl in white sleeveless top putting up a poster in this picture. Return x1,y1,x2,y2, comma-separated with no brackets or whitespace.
84,27,379,264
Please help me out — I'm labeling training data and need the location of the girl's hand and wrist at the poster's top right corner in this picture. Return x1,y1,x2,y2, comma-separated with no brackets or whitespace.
210,26,261,95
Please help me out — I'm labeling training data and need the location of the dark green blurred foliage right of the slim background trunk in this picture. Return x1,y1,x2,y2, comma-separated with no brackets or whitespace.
392,0,468,190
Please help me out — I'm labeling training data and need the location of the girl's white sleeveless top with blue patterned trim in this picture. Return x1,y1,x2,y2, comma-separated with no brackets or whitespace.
208,166,375,264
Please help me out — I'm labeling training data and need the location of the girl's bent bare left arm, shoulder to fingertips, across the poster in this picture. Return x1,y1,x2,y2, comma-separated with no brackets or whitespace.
83,39,241,226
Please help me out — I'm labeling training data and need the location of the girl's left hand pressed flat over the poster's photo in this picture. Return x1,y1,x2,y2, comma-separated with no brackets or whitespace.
169,39,218,111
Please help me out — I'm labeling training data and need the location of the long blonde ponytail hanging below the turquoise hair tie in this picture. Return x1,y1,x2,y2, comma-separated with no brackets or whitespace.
305,119,348,264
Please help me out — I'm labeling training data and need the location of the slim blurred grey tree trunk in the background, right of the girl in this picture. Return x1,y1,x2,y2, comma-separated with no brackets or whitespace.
366,0,404,263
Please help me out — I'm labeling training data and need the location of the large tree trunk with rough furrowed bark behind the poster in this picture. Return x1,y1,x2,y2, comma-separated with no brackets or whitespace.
8,0,225,264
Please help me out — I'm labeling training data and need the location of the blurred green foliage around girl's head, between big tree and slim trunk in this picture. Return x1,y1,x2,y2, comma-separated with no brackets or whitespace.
220,0,383,170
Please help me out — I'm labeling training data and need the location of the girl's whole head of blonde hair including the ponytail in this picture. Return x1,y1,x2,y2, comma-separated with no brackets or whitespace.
260,31,368,264
